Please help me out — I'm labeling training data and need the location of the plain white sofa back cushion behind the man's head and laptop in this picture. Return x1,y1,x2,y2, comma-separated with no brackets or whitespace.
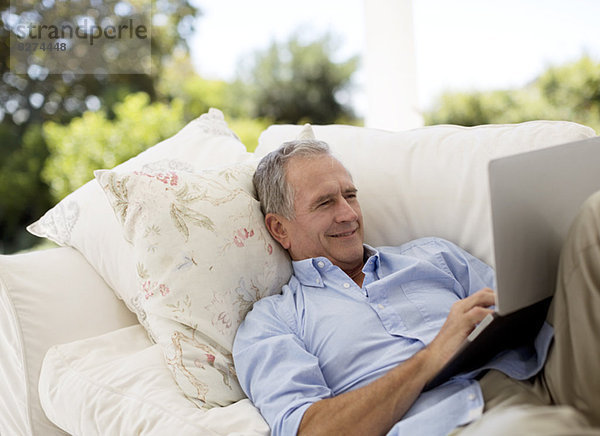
255,121,595,265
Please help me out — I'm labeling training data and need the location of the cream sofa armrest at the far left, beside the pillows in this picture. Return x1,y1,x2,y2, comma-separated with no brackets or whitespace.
0,247,137,435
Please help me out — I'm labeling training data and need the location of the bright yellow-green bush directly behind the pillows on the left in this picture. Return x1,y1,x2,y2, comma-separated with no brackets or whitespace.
42,93,183,200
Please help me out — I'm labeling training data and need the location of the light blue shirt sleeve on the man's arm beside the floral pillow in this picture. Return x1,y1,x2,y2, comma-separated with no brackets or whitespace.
233,287,332,436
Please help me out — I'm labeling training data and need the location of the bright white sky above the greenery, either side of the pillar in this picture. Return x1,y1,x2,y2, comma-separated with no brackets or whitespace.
190,0,600,114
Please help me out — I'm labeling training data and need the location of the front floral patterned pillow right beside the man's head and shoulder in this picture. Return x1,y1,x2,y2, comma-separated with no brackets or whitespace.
96,163,291,408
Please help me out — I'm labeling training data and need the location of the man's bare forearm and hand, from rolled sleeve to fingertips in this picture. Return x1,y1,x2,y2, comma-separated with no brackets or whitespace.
298,288,494,436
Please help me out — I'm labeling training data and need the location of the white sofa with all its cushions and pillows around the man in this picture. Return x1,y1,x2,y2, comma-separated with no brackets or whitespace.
0,110,595,436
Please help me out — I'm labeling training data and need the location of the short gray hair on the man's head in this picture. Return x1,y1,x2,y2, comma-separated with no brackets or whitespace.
252,139,333,219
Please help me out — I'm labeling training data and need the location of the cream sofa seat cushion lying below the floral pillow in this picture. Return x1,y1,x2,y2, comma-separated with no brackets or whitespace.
40,325,269,436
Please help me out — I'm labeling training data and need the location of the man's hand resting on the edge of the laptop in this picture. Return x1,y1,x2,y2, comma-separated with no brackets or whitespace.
427,288,495,373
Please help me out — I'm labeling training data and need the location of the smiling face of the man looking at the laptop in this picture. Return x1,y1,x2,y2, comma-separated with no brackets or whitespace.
268,155,363,271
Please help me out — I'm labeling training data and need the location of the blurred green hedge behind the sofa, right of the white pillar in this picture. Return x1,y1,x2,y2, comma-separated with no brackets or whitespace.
425,56,600,131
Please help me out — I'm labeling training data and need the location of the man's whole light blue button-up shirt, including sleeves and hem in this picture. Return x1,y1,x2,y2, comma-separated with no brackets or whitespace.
233,238,552,436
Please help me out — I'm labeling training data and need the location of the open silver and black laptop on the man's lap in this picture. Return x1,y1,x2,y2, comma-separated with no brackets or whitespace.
425,137,600,390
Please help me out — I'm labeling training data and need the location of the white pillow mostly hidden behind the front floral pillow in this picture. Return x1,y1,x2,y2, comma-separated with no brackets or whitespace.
27,109,250,313
